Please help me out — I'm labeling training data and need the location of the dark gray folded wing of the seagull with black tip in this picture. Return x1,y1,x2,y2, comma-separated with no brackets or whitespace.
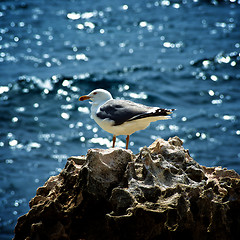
96,99,174,126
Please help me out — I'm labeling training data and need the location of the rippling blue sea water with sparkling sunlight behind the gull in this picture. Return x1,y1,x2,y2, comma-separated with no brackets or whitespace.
0,0,240,239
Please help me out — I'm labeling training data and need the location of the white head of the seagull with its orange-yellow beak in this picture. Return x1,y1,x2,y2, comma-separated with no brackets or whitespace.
79,89,112,104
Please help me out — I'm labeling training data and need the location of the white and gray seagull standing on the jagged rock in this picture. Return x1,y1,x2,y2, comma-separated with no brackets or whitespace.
79,89,175,149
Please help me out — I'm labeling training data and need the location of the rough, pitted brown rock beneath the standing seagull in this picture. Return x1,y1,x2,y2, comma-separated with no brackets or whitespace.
14,137,240,240
